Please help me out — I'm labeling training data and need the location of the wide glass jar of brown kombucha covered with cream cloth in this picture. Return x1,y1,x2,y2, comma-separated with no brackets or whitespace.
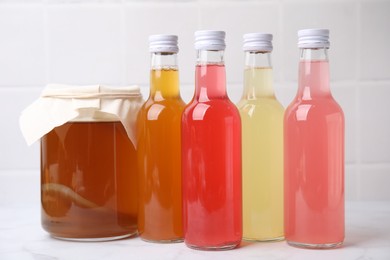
21,85,142,241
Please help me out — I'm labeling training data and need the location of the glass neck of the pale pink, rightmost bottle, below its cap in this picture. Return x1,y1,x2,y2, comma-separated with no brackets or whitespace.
297,48,331,100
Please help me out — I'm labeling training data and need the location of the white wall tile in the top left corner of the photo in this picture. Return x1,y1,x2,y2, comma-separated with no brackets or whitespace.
0,4,46,86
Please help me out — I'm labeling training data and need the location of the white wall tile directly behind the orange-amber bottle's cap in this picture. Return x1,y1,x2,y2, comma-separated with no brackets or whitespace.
124,1,198,86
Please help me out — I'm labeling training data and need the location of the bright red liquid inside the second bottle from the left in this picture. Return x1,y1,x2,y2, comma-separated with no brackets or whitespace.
182,65,242,249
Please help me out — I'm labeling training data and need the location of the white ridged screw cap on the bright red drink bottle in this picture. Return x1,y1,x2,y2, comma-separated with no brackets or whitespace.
195,31,226,51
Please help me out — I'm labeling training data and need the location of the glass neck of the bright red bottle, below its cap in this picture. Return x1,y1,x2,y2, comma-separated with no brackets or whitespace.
195,50,227,102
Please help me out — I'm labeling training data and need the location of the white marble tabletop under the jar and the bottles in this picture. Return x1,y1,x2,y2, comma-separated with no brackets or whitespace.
0,173,390,260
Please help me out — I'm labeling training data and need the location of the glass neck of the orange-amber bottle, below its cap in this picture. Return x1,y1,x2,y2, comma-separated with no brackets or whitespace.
150,52,180,101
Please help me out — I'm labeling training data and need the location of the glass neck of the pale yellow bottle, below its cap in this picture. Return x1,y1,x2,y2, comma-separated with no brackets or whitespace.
243,51,275,100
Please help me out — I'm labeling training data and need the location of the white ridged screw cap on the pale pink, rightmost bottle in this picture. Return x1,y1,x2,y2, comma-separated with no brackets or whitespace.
298,29,330,49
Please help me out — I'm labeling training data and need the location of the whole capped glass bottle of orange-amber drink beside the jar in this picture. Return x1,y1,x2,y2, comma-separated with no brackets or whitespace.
137,35,185,242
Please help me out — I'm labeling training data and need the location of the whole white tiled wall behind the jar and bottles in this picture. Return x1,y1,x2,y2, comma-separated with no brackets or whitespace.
0,0,390,200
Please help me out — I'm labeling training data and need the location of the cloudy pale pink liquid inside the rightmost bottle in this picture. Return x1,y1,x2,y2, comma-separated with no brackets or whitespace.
284,61,344,245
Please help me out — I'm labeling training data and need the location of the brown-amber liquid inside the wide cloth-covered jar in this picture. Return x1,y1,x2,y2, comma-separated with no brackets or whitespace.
41,122,137,240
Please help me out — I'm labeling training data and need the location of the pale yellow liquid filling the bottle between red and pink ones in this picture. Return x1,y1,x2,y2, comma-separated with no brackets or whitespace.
237,68,284,241
